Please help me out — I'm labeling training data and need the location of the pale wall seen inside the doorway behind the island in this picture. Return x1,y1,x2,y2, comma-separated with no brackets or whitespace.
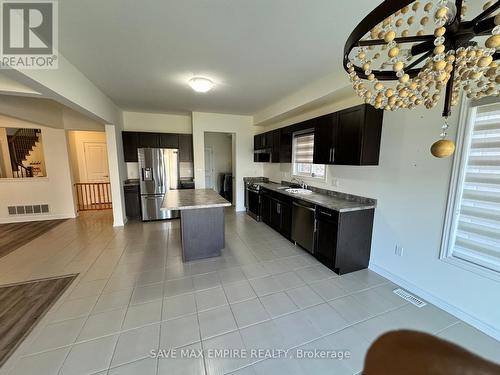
205,133,233,192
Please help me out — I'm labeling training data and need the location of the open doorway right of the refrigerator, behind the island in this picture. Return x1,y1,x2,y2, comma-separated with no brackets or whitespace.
205,132,234,203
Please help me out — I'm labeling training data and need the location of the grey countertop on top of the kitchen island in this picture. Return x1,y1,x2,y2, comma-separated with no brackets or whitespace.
161,189,231,210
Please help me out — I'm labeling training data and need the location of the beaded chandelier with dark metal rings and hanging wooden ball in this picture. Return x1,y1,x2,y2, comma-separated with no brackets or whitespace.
344,0,500,157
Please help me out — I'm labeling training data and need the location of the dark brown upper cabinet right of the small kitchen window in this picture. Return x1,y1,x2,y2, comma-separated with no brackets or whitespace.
314,104,383,165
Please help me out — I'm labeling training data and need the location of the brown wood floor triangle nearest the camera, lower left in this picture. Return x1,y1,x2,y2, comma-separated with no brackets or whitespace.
0,275,77,366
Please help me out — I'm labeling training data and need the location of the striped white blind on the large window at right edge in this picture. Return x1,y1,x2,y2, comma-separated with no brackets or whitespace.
450,104,500,272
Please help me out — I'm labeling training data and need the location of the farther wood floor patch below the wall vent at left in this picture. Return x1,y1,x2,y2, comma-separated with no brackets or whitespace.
0,220,66,258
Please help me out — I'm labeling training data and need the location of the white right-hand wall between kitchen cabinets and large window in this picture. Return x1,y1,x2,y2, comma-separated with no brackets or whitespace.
264,101,500,339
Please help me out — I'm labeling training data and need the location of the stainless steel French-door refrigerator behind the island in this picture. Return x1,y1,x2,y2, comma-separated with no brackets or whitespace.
137,148,179,221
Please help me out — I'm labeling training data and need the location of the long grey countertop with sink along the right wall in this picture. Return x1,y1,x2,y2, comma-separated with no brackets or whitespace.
259,182,377,212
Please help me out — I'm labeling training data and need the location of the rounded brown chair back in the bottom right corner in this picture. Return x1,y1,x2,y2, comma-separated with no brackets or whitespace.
363,331,500,375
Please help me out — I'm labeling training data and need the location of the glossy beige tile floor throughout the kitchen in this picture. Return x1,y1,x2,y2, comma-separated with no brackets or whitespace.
0,210,500,375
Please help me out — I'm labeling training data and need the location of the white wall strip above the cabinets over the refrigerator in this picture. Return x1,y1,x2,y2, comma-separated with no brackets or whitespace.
123,111,192,134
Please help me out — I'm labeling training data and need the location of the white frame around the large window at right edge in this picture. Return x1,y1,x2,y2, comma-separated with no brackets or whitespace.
439,95,500,281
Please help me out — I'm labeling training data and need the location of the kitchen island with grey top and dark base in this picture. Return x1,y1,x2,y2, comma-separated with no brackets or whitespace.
161,189,231,262
